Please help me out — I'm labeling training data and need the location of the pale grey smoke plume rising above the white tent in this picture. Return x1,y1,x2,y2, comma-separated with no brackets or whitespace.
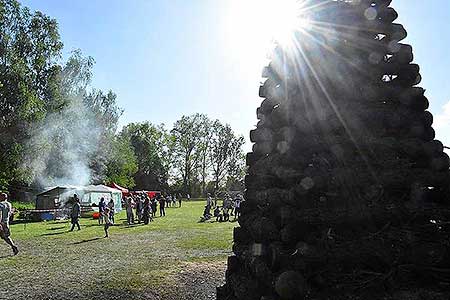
24,97,101,187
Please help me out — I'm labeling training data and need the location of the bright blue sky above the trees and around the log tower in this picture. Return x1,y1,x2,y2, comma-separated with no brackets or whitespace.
21,0,450,147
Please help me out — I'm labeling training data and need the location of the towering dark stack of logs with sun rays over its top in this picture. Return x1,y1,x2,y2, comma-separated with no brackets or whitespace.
217,0,450,300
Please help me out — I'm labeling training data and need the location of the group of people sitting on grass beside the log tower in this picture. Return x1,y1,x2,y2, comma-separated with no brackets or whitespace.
202,194,244,222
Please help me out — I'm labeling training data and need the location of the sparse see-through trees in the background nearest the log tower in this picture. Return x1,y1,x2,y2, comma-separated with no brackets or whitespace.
171,114,245,196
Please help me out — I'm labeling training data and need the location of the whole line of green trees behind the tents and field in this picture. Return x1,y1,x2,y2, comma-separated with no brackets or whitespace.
0,0,244,196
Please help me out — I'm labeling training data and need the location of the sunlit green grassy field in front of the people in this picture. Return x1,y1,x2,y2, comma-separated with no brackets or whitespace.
0,202,237,299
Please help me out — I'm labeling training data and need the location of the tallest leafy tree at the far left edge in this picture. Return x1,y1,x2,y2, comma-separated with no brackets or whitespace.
0,0,62,187
